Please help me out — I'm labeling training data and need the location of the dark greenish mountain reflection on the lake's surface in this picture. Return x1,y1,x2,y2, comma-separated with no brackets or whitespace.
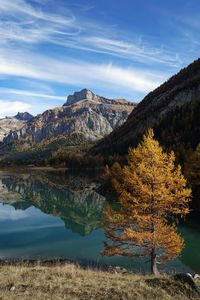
0,173,106,236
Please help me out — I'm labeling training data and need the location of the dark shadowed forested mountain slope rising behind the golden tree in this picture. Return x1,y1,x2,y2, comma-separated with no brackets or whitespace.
91,59,200,159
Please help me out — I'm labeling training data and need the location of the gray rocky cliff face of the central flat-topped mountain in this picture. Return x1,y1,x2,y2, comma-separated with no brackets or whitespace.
4,89,135,144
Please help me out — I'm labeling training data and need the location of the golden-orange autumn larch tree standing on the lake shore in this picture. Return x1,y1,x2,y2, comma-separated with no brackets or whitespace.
103,129,191,274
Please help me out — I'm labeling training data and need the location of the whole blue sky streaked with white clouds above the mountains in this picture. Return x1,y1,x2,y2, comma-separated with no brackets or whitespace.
0,0,200,118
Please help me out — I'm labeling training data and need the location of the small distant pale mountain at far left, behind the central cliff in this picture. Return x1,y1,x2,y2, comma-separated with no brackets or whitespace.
0,112,33,142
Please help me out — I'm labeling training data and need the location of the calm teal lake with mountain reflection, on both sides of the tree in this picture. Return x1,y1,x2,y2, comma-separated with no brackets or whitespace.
0,170,200,272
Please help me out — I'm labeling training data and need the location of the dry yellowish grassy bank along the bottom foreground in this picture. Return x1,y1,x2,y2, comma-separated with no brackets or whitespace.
0,263,199,300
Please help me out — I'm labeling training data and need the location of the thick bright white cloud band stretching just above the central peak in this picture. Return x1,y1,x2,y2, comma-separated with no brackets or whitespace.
0,48,166,92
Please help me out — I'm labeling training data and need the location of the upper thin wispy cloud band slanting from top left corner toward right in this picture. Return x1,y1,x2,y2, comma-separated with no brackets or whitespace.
0,0,181,67
